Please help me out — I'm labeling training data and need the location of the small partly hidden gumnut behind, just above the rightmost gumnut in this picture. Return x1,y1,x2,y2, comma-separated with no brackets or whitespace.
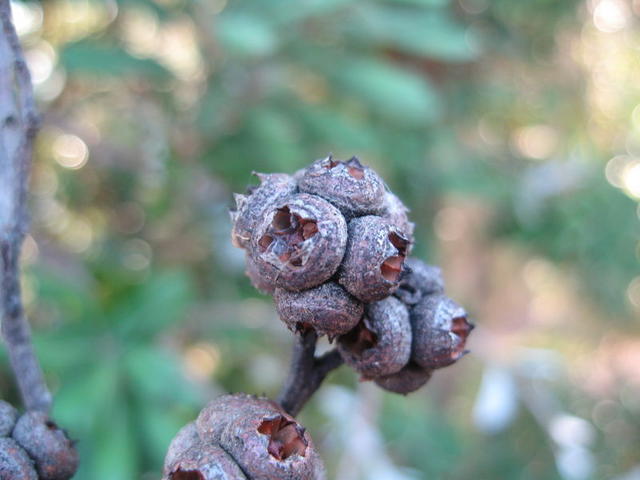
394,257,444,305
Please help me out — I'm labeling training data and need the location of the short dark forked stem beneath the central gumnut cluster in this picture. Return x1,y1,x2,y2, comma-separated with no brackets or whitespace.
278,329,344,416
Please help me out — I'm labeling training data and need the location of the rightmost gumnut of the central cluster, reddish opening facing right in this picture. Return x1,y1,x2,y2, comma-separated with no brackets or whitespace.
411,294,473,369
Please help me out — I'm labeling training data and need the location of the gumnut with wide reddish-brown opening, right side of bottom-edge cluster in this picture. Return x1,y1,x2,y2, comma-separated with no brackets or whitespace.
220,408,325,480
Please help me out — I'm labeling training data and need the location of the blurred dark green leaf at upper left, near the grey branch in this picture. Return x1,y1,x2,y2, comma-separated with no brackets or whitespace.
61,41,170,80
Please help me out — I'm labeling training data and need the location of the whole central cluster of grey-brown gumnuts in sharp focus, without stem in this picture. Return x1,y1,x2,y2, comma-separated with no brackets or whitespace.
231,156,473,394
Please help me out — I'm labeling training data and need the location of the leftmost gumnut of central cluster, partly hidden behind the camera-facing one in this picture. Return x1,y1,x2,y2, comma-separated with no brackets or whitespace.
230,173,298,248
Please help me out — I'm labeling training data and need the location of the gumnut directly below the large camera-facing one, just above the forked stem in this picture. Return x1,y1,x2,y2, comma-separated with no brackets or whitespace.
275,282,364,339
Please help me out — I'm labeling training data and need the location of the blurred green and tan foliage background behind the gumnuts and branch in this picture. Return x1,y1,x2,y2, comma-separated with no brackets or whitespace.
0,0,640,480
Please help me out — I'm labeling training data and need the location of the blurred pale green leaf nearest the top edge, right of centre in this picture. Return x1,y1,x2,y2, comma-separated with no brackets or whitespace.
347,6,479,62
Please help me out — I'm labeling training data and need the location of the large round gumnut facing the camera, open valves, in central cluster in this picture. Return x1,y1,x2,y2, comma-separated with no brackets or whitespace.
251,193,347,291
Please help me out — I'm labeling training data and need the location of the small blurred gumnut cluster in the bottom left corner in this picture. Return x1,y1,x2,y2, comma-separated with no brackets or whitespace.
0,400,78,480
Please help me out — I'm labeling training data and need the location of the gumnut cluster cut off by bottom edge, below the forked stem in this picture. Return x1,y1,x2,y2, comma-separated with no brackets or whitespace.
163,393,325,480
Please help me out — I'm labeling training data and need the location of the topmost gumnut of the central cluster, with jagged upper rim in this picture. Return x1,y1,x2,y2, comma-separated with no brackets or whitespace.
299,156,385,218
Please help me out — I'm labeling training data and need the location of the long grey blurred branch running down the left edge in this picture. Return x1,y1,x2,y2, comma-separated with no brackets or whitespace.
0,0,51,412
